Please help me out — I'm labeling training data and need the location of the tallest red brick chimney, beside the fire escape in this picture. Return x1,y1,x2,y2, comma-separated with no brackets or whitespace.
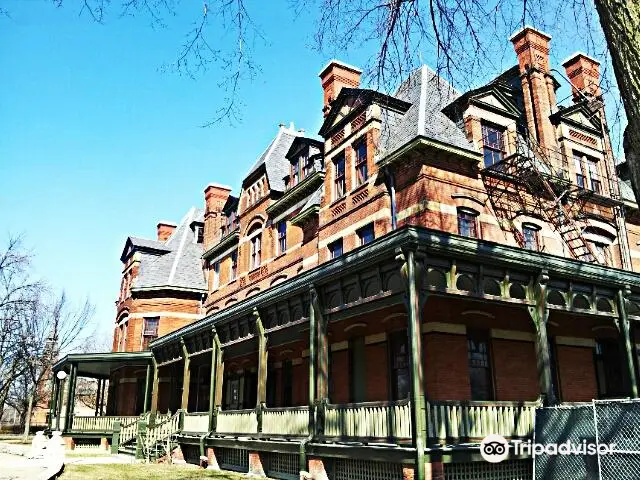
510,26,557,148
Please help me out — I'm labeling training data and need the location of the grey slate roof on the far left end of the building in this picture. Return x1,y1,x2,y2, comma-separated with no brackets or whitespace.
133,208,207,291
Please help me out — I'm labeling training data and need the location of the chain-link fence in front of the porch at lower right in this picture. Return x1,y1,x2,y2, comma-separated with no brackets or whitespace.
533,400,640,480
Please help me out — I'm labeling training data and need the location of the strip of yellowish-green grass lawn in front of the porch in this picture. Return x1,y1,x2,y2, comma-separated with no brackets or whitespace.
60,464,251,480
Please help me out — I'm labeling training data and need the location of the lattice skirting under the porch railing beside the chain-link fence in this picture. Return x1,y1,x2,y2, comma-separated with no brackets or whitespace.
444,460,533,480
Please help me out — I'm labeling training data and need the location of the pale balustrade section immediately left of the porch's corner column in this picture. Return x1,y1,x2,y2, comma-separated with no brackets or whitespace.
324,400,411,442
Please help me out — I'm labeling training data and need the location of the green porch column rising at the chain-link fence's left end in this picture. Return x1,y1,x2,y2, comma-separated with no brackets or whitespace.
528,271,557,405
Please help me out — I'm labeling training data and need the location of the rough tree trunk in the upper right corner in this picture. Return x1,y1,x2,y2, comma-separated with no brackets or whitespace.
595,0,640,200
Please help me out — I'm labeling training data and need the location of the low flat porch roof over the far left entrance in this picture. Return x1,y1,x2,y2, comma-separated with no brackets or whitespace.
53,351,151,378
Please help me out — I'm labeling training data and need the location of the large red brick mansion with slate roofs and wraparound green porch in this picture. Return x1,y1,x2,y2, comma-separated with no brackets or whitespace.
49,27,640,480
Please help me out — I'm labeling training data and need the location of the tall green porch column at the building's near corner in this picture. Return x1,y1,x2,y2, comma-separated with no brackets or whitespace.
401,248,426,480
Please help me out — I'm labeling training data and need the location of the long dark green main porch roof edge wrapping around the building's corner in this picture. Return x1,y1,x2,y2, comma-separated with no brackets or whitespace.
151,226,640,349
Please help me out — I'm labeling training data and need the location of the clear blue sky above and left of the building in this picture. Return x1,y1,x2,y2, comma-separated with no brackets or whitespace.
0,0,624,343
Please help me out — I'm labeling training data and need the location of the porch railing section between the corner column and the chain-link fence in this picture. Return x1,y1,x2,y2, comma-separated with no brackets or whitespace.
426,401,540,443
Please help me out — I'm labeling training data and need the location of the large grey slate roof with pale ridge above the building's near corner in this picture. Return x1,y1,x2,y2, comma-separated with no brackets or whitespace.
382,65,478,153
